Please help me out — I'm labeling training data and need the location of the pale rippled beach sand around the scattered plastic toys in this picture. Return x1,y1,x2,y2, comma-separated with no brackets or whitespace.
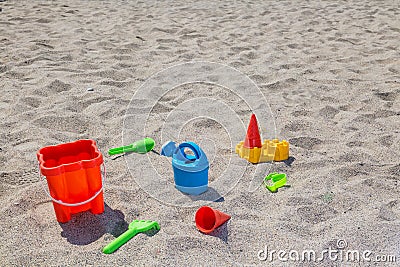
0,0,400,266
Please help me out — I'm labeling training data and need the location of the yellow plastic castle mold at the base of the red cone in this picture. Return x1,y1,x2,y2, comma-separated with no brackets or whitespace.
235,139,289,163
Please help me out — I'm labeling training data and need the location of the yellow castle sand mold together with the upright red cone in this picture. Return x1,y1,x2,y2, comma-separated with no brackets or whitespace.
235,114,289,163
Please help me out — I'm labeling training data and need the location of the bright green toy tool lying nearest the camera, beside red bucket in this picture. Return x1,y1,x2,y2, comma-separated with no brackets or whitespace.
103,220,160,254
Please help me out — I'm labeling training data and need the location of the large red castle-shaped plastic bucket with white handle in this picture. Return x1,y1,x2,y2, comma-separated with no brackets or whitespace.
37,140,105,223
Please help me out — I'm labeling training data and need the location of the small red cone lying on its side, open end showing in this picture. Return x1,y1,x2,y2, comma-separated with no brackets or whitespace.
195,206,231,234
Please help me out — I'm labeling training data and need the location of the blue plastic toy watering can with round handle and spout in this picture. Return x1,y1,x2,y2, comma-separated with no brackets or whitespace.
161,141,209,195
